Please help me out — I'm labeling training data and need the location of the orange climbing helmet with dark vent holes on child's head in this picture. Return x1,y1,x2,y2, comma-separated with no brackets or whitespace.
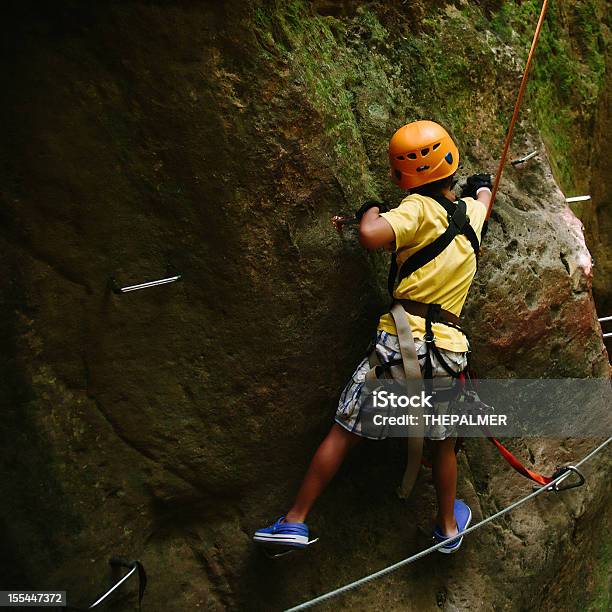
389,121,459,189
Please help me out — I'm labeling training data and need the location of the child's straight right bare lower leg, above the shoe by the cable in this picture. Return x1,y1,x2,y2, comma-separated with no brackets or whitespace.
431,438,458,536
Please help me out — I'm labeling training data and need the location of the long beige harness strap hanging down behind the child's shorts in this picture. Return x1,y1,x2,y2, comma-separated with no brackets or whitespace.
391,302,425,498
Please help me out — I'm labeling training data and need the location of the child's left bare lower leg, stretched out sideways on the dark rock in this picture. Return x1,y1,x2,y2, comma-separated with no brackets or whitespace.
285,423,361,523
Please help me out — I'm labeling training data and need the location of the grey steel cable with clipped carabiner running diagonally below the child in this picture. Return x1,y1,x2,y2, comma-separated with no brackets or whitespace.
285,437,612,612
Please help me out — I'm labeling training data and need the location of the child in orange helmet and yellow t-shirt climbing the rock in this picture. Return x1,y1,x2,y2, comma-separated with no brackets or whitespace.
253,121,491,553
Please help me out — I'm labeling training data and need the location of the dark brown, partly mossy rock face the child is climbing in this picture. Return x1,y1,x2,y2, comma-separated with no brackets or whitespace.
0,1,609,612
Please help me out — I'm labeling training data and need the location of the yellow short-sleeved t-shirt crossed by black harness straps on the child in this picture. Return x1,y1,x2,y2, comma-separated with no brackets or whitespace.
378,194,487,352
